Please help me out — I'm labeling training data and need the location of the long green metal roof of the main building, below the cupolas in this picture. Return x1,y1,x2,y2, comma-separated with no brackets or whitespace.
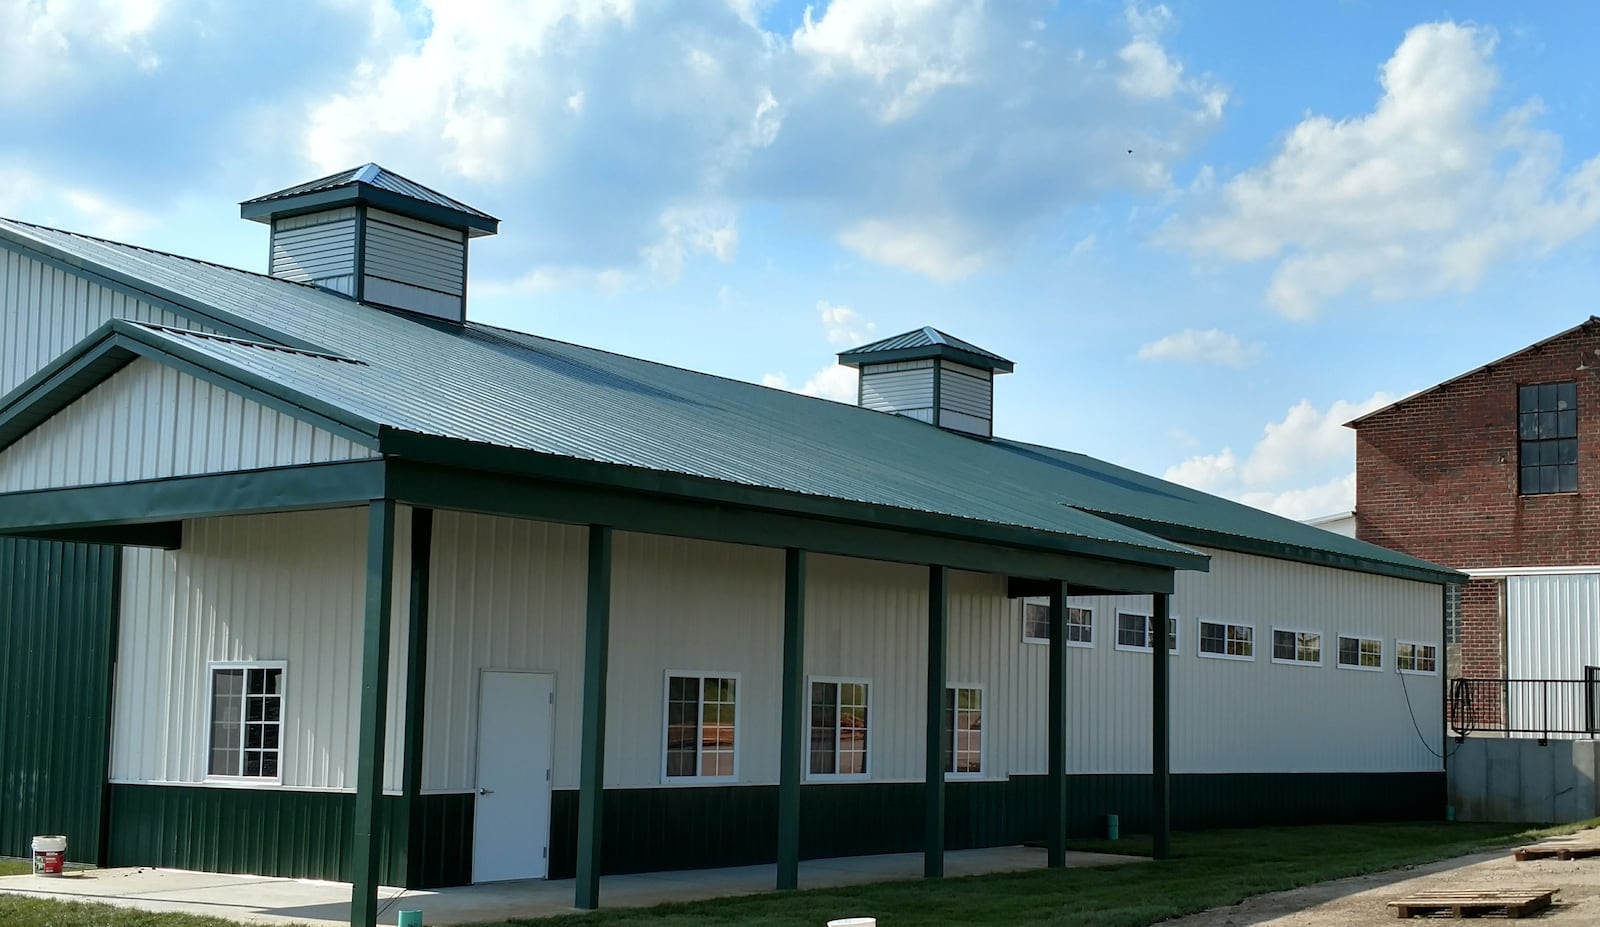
0,219,1459,583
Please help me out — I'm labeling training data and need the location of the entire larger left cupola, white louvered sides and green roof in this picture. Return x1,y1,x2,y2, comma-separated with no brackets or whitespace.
238,163,499,322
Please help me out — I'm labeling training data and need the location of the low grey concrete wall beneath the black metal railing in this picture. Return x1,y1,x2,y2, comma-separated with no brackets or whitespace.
1445,736,1600,823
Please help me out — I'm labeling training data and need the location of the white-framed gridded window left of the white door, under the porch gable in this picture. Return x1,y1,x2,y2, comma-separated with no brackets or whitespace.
206,661,288,781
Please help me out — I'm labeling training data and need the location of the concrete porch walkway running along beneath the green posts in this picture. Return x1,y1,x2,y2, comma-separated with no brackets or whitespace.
0,847,1141,927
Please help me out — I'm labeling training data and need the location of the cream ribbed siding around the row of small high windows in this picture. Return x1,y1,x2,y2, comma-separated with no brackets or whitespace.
1043,551,1443,773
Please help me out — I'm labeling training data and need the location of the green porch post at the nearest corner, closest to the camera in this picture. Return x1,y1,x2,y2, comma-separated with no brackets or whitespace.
350,500,395,927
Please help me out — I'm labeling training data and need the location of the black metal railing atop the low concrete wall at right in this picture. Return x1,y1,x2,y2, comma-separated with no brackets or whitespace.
1445,666,1600,743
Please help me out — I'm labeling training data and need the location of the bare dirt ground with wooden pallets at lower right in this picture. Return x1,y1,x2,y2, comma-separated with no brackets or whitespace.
1162,831,1600,927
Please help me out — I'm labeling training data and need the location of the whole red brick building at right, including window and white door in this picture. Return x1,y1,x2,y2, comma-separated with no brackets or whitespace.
1349,317,1600,704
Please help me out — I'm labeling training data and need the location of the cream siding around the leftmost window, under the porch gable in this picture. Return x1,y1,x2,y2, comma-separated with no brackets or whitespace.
110,508,411,793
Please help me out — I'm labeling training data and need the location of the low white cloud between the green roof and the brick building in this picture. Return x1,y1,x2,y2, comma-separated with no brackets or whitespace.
1163,392,1395,519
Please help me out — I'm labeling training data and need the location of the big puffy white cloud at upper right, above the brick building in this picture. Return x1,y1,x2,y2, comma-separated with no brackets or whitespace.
1163,22,1600,319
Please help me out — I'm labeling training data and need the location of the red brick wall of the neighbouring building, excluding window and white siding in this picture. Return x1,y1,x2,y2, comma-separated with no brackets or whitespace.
1355,323,1600,677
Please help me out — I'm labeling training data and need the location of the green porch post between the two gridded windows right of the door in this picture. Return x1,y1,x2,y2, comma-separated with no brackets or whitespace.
778,548,806,890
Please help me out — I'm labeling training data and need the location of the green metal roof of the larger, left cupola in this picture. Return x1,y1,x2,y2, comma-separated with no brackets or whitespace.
238,163,499,237
